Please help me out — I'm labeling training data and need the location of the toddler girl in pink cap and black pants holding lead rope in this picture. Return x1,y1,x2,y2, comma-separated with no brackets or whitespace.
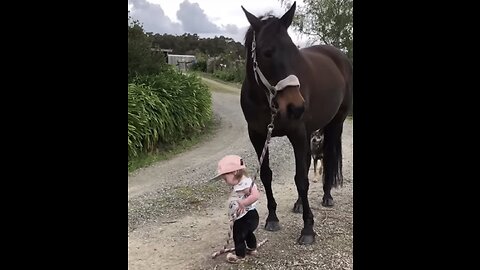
214,155,260,263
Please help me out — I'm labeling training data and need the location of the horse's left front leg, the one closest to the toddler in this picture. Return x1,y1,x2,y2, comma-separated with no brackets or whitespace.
248,129,280,231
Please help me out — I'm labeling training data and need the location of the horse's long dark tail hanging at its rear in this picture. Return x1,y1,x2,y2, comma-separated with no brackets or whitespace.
322,111,347,189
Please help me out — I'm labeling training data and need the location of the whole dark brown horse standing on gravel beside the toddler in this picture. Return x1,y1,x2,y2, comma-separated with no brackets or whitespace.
240,3,353,244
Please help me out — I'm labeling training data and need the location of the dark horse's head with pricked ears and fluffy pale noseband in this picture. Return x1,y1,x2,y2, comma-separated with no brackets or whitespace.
242,2,305,119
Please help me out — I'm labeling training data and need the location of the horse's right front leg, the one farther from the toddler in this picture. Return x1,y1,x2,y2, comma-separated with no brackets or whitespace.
288,134,315,245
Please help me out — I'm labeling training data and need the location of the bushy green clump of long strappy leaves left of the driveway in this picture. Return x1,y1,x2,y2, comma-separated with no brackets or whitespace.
128,68,212,161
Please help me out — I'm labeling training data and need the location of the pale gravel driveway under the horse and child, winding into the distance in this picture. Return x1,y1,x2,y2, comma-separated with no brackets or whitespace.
128,79,353,270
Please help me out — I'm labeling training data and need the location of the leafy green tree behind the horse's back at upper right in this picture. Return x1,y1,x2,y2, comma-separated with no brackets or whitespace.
280,0,353,60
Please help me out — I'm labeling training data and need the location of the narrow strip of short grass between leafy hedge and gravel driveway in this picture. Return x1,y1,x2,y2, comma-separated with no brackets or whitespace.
128,117,219,173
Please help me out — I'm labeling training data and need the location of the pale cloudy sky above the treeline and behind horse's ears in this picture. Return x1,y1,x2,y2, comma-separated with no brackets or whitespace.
128,0,307,47
